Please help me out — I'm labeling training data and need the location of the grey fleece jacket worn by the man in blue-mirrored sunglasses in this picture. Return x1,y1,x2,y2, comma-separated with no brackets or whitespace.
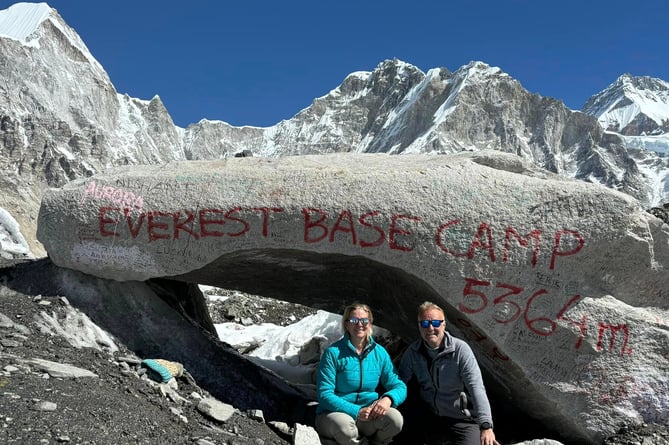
399,332,493,425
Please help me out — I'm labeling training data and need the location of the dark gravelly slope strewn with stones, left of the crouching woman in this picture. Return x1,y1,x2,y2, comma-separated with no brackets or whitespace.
0,272,292,445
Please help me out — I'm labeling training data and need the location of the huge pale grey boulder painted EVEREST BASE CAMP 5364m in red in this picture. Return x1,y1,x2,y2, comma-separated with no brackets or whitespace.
37,152,669,443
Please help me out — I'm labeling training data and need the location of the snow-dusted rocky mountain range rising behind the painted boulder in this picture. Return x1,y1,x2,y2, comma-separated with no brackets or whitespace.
0,3,669,254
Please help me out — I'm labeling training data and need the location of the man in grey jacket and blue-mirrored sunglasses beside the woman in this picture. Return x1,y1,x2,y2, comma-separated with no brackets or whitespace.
399,301,497,445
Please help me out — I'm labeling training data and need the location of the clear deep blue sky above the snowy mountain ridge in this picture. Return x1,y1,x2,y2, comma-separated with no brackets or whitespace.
10,0,669,127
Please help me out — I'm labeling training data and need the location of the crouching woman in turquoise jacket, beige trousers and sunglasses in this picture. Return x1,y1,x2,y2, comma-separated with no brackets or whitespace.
316,303,407,445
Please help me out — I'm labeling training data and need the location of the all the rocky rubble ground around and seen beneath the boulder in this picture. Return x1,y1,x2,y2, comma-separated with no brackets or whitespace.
0,270,669,445
